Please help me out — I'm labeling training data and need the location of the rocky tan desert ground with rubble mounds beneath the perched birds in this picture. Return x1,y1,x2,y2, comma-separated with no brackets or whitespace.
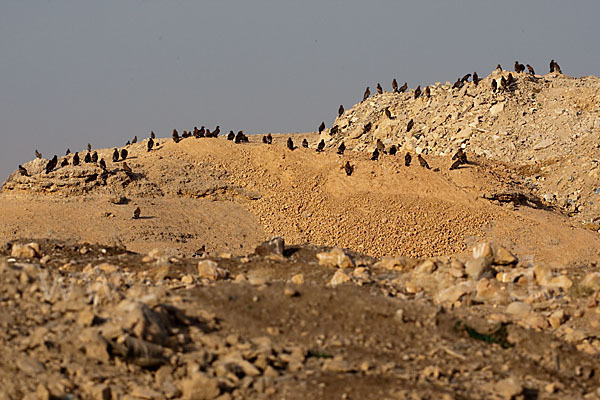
0,70,600,400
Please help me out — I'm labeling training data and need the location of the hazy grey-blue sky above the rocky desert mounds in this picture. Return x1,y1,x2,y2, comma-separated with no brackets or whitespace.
0,0,600,180
